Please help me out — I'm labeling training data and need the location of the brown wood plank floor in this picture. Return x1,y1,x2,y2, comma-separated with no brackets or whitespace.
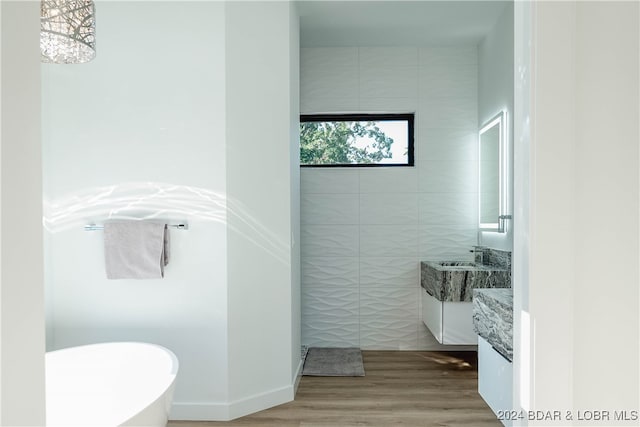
168,351,501,427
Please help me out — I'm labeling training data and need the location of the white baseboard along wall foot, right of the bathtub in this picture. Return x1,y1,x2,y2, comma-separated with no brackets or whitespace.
169,385,294,421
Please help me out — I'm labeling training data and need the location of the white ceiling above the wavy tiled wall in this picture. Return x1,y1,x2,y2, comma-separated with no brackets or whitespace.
298,0,508,47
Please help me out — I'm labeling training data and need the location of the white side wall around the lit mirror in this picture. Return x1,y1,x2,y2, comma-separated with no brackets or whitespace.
478,2,517,251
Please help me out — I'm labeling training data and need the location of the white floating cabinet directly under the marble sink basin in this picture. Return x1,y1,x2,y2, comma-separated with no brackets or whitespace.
422,288,477,345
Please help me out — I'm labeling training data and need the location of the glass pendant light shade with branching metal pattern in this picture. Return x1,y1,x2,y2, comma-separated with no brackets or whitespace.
40,0,96,64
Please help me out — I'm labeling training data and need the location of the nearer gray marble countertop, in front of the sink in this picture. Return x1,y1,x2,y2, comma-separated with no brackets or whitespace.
473,289,513,362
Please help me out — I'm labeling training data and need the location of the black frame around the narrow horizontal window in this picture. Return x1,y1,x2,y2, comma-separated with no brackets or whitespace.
300,113,415,168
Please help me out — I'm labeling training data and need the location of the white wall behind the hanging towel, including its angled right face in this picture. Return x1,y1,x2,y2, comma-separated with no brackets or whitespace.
43,2,300,420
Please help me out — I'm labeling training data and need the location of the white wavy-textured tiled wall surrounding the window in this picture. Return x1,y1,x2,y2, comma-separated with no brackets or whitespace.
301,46,478,350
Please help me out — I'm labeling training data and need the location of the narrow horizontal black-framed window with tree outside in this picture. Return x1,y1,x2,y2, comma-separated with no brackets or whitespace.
300,114,413,167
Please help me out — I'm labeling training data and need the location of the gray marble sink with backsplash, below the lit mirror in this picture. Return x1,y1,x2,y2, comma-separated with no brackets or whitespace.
420,261,511,302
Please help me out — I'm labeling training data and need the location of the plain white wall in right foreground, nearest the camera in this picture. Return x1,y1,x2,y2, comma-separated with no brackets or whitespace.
514,2,640,425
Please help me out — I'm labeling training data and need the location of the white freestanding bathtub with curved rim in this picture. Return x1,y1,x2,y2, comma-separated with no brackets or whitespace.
45,342,178,427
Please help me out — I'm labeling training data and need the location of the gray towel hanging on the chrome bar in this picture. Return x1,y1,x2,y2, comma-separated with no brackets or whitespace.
104,221,169,279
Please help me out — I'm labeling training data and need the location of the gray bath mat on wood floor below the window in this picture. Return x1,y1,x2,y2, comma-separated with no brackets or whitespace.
302,347,364,377
